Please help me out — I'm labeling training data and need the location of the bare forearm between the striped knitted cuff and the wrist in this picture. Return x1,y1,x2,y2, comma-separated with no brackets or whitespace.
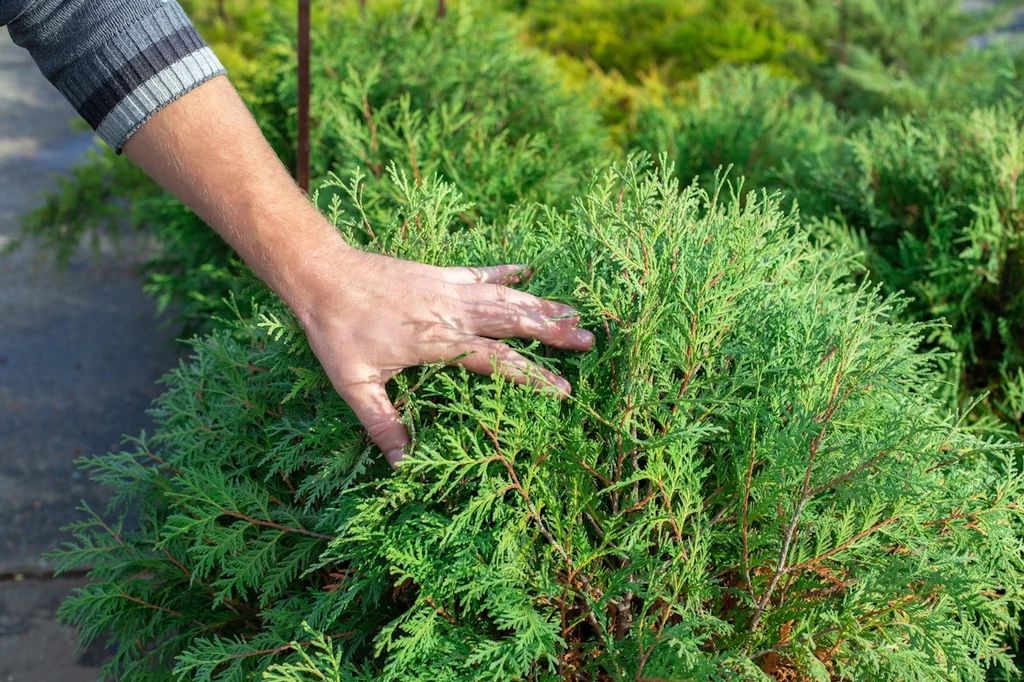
124,77,347,318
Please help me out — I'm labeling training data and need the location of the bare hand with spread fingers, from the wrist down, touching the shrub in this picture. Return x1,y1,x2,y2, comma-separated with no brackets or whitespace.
296,240,594,466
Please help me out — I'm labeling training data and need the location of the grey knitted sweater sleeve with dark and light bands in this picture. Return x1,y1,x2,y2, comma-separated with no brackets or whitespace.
0,0,224,154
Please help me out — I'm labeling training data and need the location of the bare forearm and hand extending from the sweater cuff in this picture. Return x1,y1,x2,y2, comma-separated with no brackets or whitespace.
117,78,594,465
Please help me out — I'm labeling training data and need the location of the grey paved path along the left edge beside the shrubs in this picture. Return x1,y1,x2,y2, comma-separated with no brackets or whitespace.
0,28,176,682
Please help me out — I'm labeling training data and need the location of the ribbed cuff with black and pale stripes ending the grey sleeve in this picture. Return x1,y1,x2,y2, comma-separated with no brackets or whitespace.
54,2,225,154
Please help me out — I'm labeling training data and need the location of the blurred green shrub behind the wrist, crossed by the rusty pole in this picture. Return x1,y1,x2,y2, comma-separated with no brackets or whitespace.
266,3,607,222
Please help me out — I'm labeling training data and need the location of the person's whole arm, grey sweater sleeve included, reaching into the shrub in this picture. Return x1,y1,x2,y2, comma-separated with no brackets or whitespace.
0,0,593,463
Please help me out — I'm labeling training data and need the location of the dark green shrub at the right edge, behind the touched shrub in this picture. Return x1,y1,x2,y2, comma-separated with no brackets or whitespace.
801,106,1024,434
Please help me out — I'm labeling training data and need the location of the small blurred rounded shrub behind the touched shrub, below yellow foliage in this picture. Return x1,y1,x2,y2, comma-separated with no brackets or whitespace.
629,67,848,204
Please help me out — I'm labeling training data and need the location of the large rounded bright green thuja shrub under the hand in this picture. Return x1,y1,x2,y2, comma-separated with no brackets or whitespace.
52,161,1024,682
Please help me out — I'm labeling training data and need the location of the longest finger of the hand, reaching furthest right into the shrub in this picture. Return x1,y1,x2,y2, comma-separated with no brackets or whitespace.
465,302,594,350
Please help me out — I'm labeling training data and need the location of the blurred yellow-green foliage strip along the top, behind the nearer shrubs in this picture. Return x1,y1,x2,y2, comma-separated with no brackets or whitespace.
176,0,1020,133
